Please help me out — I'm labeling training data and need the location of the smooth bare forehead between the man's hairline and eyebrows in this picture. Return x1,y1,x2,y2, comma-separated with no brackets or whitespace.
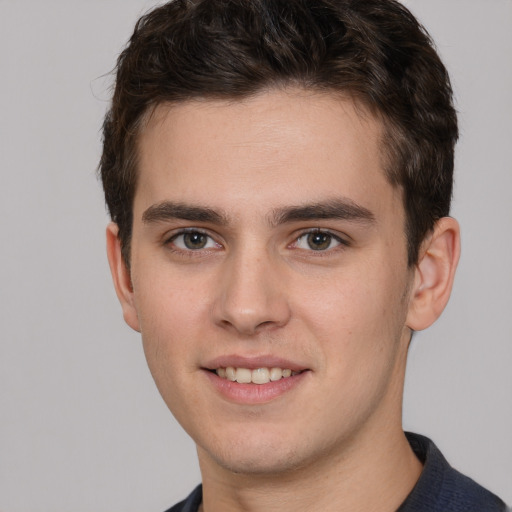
134,89,396,220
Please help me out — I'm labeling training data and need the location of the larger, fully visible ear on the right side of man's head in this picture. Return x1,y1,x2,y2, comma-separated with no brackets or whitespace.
406,217,460,331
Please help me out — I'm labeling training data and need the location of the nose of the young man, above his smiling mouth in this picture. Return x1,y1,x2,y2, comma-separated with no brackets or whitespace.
214,247,290,336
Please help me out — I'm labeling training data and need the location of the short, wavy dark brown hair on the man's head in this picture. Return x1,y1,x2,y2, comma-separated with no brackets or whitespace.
99,0,458,265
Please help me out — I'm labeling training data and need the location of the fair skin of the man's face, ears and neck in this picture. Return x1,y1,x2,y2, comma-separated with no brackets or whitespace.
107,89,459,512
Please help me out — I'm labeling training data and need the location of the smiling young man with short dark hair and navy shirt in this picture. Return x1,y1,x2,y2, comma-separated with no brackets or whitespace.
100,0,505,512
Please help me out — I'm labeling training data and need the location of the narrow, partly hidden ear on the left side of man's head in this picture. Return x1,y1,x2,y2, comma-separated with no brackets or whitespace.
107,222,140,332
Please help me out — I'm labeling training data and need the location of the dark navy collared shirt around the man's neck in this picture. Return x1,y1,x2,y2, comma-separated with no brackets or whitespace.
167,433,510,512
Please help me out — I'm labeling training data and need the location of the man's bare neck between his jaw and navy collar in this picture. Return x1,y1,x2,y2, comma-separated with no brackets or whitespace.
199,428,422,512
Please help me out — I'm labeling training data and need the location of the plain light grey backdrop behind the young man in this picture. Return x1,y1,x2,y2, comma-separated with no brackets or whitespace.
0,0,512,512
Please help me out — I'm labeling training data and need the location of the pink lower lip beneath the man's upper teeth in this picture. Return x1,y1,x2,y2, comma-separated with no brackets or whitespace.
203,370,310,405
